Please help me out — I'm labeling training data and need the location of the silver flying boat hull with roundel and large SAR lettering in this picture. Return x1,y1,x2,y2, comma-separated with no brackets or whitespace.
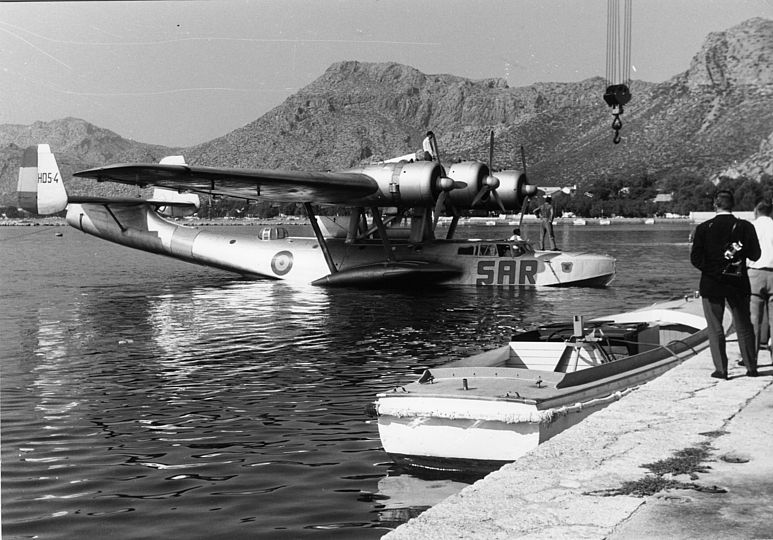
67,203,615,287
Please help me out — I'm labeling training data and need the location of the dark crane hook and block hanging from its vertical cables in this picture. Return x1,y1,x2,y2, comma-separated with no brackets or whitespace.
604,0,632,144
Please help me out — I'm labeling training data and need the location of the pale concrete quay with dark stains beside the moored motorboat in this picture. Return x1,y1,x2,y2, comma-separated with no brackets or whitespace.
383,338,773,540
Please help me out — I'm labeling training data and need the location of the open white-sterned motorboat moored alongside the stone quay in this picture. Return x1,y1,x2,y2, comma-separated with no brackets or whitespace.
371,297,708,472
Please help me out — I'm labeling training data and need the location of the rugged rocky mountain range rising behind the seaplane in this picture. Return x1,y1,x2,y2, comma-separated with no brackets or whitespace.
0,18,773,204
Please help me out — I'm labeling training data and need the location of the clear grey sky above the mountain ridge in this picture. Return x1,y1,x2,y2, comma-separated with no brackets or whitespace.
0,0,773,146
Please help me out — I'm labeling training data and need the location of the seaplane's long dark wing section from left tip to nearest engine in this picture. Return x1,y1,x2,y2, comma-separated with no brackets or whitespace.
73,163,378,204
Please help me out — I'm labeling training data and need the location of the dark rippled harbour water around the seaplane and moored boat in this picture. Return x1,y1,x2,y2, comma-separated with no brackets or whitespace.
0,221,697,538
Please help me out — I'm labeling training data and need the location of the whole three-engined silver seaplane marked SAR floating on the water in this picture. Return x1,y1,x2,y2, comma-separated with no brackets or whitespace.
18,132,615,287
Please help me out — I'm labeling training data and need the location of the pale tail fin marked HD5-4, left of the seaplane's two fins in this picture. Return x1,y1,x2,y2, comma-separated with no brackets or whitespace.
16,144,67,215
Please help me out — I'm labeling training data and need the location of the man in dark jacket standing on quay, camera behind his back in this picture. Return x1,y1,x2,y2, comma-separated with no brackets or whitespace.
690,190,760,379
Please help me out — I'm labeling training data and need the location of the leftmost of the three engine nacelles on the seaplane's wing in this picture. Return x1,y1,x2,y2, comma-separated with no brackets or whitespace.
351,161,441,207
